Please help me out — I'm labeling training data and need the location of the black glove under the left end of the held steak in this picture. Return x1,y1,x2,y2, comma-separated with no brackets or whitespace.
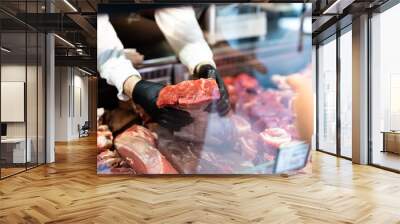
132,80,193,131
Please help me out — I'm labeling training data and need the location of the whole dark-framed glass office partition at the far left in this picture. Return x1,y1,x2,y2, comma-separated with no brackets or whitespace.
0,1,46,179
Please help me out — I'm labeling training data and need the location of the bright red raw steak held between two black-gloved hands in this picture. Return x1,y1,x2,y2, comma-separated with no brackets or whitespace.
157,79,220,108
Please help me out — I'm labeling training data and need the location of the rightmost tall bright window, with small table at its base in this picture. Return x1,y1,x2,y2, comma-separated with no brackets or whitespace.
370,2,400,170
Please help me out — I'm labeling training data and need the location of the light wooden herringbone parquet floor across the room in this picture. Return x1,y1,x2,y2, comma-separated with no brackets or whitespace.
0,138,400,224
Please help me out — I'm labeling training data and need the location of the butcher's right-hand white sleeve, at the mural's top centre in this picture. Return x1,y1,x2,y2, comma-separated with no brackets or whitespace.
155,7,215,74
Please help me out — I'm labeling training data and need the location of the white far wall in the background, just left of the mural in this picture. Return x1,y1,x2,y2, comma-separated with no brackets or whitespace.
55,67,88,141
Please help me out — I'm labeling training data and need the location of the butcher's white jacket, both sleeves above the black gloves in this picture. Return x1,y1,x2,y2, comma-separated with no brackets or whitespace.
97,7,215,101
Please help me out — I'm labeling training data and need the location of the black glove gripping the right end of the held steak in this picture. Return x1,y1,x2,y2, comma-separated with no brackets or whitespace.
194,64,231,116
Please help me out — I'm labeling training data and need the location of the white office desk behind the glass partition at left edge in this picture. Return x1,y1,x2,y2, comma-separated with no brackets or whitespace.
1,138,32,163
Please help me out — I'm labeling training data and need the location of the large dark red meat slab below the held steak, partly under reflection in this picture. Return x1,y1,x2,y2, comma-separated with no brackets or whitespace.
155,115,261,174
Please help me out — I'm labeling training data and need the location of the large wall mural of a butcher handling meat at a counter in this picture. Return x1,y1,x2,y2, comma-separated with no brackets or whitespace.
97,3,314,175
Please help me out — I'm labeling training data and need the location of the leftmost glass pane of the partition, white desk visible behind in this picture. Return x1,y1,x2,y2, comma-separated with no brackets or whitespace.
1,32,27,177
